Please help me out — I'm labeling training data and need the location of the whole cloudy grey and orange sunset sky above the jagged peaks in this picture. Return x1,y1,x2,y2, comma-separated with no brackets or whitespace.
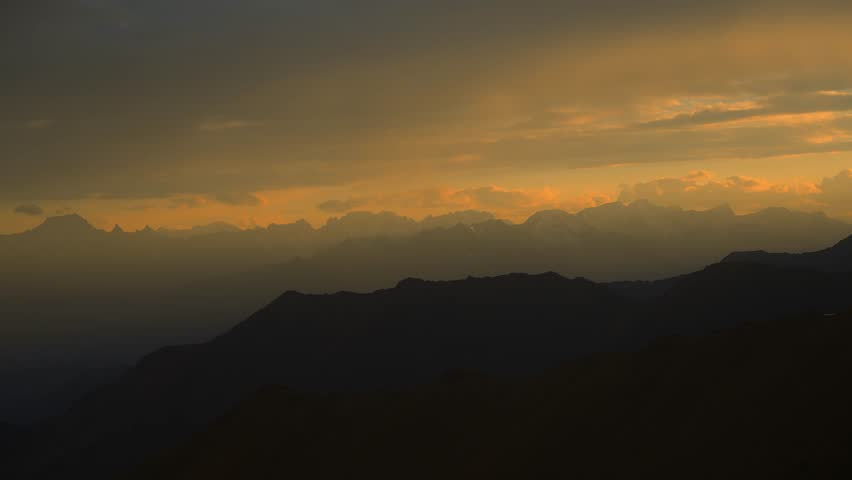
5,0,852,233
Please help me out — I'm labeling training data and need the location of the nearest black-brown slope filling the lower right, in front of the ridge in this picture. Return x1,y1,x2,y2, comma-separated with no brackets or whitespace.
128,314,852,480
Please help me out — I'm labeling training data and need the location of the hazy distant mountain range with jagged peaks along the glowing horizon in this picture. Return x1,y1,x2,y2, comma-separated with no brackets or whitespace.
0,201,852,421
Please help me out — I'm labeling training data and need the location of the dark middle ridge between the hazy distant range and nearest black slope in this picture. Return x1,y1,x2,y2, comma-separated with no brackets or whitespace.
10,263,852,478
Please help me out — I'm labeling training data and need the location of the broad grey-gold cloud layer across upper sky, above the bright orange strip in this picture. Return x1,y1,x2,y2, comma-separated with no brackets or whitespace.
5,0,852,201
